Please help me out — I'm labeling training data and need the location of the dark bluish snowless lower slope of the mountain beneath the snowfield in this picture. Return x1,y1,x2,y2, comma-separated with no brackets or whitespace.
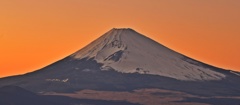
0,57,240,96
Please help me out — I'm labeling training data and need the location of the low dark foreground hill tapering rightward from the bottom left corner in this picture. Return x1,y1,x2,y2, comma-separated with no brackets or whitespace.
0,86,139,105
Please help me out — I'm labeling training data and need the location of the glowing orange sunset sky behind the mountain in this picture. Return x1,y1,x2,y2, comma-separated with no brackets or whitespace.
0,0,240,77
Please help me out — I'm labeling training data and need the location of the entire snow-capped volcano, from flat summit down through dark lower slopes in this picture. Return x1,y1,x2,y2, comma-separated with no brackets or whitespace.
0,28,240,105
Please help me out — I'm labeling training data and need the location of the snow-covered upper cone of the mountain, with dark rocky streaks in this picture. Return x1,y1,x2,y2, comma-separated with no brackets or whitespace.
72,29,225,81
